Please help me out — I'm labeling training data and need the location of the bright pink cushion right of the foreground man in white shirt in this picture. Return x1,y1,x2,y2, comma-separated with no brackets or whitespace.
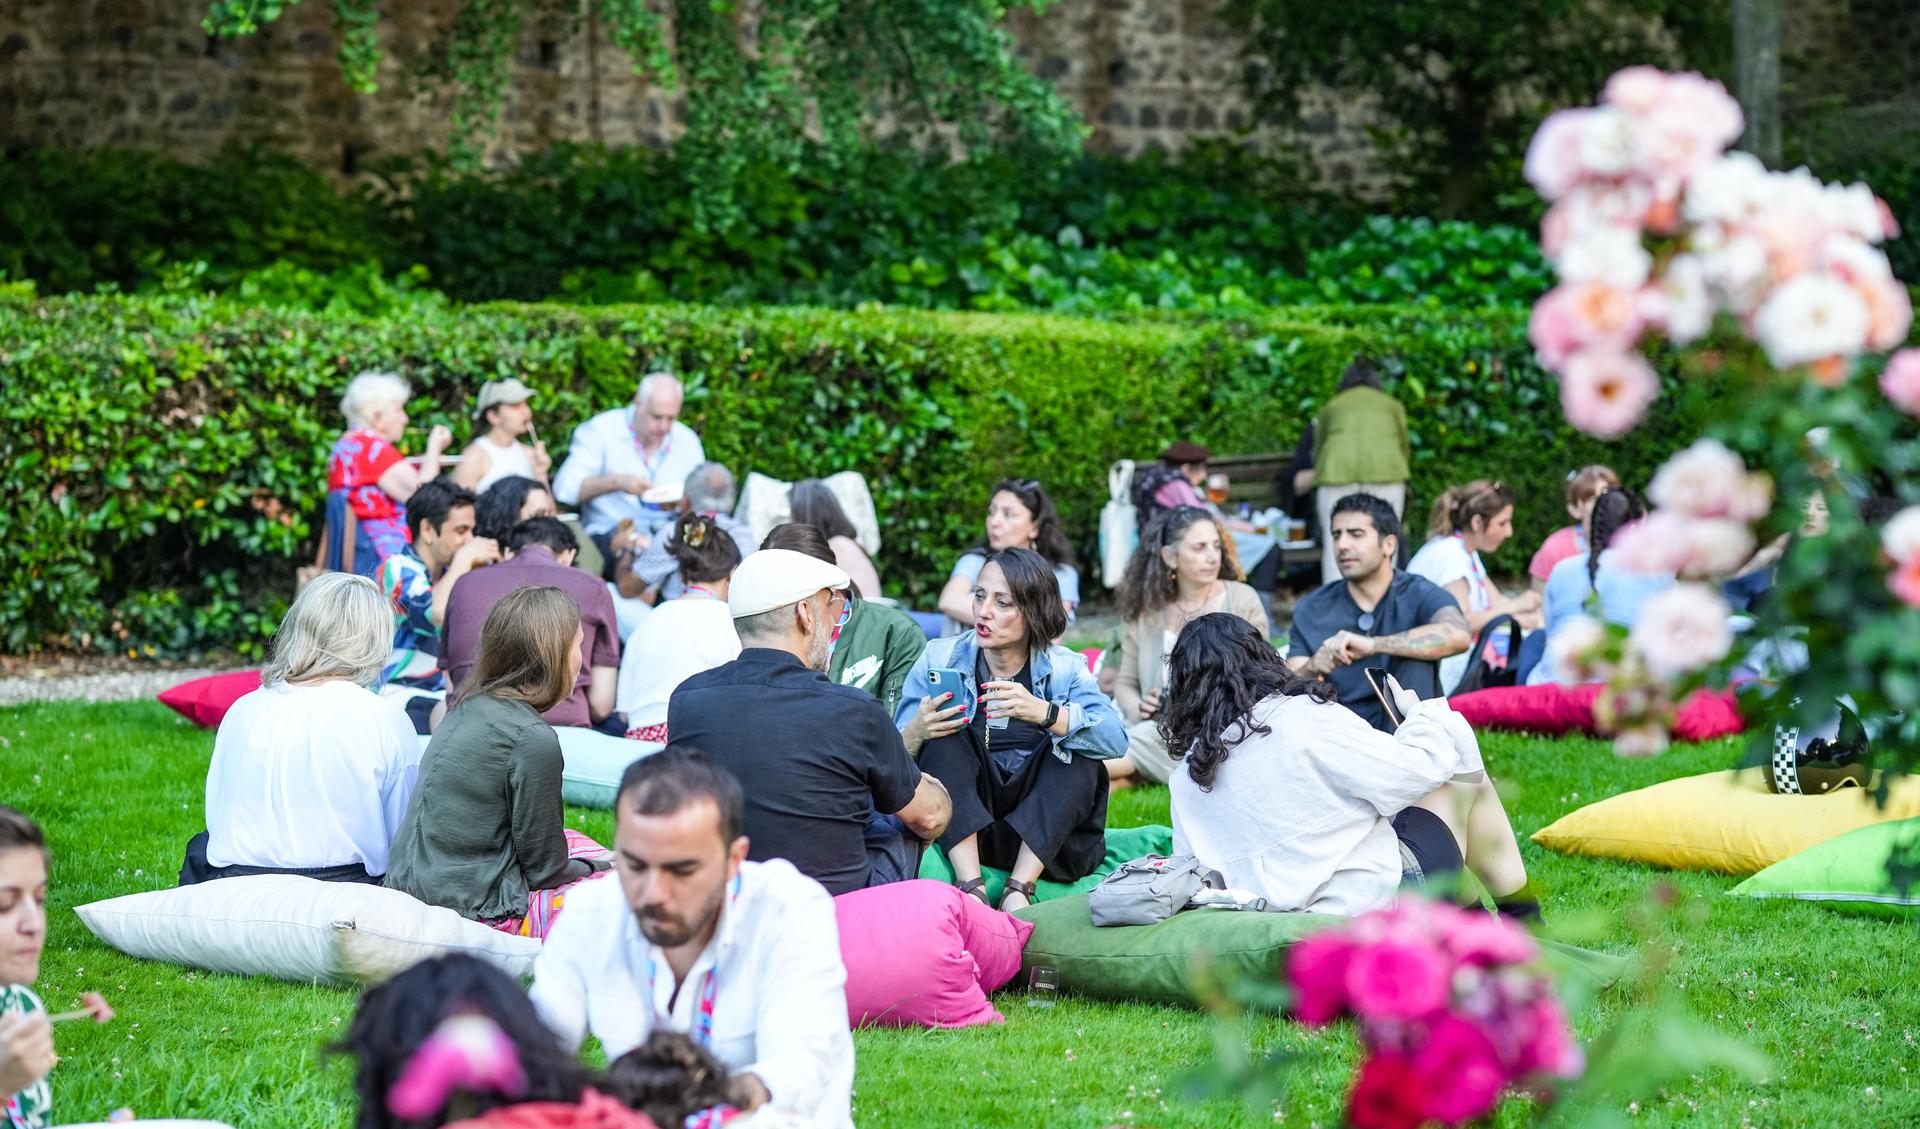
833,879,1033,1027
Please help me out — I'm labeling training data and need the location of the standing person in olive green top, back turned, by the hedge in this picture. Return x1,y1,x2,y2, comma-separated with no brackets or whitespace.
1313,361,1411,584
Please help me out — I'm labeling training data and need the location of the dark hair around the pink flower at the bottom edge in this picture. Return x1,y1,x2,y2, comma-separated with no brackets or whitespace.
326,954,595,1129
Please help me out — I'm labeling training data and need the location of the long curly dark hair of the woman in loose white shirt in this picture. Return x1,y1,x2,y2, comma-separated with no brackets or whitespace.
1160,613,1338,791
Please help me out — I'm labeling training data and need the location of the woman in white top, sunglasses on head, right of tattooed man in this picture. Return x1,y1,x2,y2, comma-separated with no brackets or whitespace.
1407,478,1540,691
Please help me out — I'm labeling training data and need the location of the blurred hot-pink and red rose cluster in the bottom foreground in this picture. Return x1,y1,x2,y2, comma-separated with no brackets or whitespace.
1286,901,1586,1129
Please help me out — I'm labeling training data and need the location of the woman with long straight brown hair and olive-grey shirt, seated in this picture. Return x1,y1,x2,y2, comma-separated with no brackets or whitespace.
384,588,612,937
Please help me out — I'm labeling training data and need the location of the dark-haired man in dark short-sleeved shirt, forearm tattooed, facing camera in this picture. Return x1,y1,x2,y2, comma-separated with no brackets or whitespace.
1286,493,1473,733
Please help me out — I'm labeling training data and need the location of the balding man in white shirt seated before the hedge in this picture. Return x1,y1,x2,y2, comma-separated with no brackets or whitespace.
553,372,707,545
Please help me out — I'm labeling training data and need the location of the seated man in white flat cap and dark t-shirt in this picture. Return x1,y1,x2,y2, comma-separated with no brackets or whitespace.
666,549,952,895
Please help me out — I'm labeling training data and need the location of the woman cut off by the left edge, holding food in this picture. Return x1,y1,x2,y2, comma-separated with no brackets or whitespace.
0,805,60,1129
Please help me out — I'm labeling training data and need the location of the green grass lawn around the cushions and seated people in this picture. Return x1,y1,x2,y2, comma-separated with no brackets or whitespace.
11,703,1920,1129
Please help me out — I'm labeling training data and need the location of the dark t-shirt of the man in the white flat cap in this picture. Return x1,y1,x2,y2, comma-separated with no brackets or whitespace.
666,647,920,895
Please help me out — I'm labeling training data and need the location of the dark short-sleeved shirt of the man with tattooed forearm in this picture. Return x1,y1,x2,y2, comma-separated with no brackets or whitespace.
1286,572,1459,733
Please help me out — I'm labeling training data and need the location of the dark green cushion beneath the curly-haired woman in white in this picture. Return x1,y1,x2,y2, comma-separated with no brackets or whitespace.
1014,895,1626,1008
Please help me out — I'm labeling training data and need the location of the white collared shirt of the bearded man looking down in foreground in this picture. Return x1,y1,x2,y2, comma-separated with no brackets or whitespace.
532,858,852,1129
